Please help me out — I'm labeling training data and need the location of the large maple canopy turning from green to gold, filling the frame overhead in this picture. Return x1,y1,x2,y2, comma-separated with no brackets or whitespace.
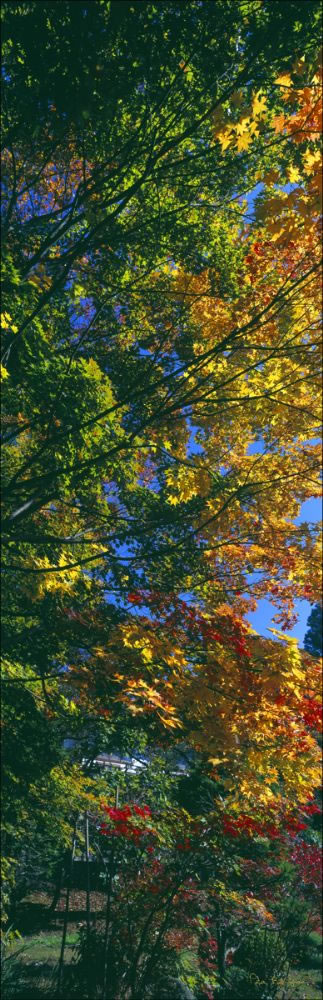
2,0,321,989
